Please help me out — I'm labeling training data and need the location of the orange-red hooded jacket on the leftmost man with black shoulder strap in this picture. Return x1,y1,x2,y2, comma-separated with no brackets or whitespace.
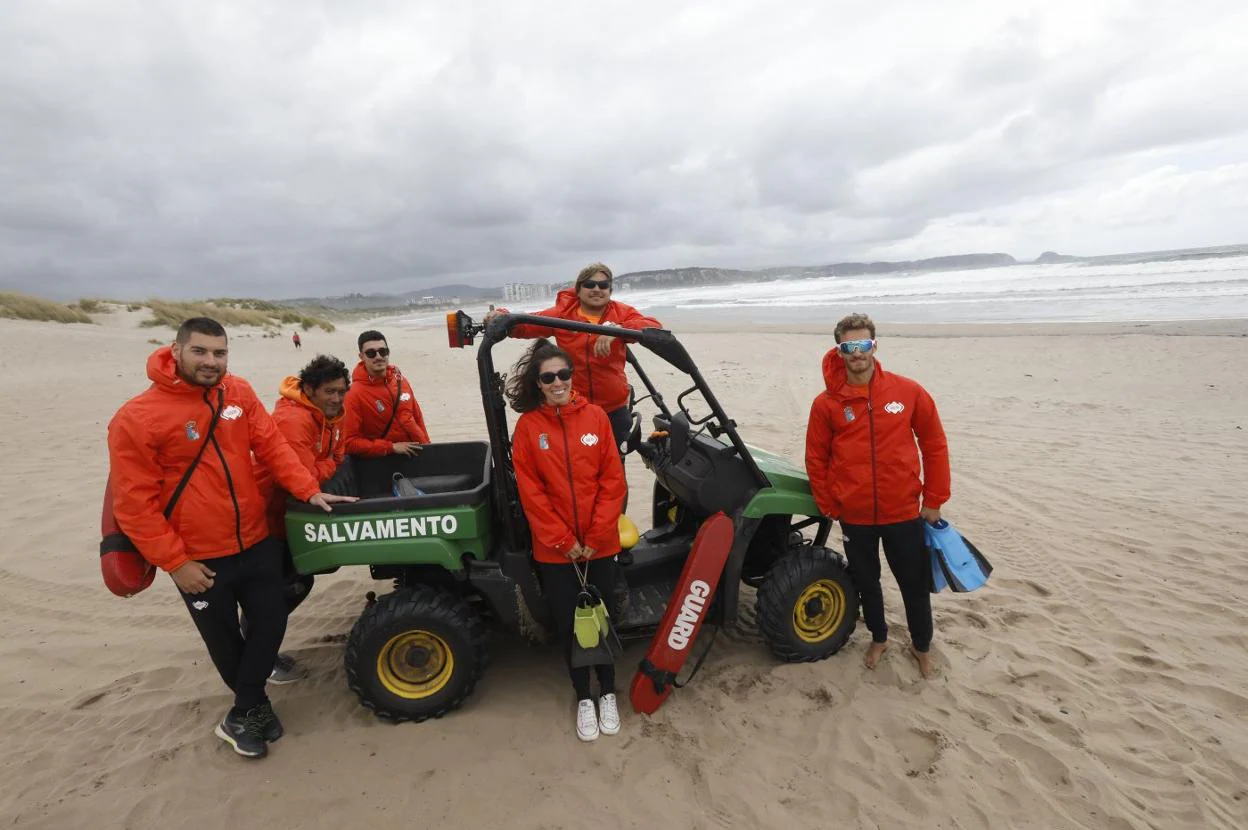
109,346,321,570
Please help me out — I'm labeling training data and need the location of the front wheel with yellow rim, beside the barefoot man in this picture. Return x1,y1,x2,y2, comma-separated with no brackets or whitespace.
756,545,859,663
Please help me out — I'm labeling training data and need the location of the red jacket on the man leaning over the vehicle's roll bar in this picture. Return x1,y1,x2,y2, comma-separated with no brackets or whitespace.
502,288,663,412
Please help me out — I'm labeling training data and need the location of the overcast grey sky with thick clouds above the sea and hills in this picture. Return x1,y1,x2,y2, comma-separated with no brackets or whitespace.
0,0,1248,297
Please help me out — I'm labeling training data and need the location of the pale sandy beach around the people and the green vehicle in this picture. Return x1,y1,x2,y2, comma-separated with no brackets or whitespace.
0,315,1248,830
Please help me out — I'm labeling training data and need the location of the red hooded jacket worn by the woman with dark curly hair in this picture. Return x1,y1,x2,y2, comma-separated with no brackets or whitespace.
512,393,626,564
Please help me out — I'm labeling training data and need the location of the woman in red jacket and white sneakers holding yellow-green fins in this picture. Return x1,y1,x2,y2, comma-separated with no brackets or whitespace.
507,339,625,740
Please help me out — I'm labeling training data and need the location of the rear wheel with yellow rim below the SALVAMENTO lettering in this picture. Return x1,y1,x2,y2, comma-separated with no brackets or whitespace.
344,585,489,723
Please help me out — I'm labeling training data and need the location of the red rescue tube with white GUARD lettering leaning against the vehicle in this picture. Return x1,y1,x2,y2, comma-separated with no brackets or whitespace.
628,513,735,715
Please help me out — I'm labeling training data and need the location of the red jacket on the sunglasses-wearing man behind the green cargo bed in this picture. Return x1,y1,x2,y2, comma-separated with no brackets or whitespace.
342,361,429,456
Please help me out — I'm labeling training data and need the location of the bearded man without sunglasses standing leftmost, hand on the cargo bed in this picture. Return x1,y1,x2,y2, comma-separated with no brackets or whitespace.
109,317,354,758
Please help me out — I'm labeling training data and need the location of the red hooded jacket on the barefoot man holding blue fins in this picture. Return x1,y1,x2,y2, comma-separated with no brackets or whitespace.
806,348,950,524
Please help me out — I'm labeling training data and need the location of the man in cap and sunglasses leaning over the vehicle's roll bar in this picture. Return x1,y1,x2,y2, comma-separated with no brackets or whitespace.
485,262,663,449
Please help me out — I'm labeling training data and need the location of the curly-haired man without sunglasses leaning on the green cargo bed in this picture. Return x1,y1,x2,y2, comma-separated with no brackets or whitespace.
256,354,349,685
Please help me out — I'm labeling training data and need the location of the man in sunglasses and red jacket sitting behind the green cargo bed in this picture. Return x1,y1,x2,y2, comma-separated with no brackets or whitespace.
342,331,429,457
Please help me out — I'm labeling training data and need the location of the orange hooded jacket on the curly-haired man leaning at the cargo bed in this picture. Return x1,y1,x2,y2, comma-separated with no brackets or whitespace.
256,376,346,539
